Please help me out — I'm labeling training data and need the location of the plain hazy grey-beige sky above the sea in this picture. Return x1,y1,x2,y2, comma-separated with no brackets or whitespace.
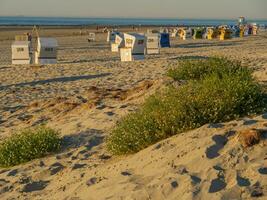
0,0,267,19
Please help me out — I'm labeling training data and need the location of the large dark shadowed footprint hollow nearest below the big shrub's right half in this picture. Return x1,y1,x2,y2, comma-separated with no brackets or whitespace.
206,135,228,159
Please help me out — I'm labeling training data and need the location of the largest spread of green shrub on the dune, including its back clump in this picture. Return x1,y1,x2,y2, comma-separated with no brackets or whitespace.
107,58,265,155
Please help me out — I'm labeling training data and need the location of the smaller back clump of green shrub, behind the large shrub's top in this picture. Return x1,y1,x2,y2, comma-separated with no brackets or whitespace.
167,57,251,81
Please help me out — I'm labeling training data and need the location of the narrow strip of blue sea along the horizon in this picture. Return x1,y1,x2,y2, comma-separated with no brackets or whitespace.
0,16,267,26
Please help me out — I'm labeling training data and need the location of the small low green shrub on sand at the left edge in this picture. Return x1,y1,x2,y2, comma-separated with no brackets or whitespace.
0,126,61,167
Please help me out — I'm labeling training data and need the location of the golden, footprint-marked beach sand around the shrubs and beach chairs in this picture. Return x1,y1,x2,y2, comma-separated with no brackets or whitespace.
0,28,267,200
